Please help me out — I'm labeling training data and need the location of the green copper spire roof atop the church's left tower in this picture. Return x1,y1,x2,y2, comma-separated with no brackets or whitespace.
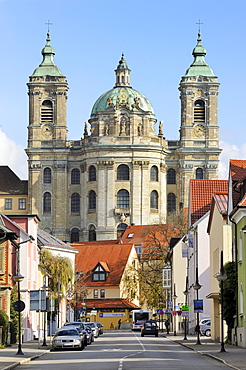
32,32,63,76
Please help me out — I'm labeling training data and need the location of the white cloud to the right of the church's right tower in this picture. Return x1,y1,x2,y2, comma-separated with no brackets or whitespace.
219,141,246,180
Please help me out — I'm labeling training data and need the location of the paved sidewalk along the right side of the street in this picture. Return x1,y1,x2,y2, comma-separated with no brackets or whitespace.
165,332,246,370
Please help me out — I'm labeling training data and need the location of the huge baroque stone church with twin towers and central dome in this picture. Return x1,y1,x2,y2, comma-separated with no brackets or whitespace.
26,33,221,242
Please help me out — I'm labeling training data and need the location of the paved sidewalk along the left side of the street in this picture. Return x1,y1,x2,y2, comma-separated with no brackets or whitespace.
0,340,51,370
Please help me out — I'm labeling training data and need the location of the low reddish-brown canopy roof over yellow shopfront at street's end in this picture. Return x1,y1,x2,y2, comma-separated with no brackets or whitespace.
78,298,140,309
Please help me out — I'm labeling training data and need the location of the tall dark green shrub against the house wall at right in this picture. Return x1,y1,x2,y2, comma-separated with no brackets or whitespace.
220,262,237,343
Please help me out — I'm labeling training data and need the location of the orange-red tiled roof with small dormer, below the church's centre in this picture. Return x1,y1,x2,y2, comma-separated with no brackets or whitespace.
73,241,133,287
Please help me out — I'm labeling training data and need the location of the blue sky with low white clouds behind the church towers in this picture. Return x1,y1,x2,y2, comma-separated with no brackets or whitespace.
0,0,246,179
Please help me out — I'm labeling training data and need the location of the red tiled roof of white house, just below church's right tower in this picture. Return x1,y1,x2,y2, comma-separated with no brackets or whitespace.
189,180,228,225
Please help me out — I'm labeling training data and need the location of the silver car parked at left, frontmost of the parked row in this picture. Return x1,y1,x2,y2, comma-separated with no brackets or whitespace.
52,326,84,350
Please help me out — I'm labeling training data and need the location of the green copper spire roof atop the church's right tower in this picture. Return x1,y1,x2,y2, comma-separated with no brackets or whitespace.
185,33,214,77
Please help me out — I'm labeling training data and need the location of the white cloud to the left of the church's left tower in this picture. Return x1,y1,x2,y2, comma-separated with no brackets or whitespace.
0,130,27,180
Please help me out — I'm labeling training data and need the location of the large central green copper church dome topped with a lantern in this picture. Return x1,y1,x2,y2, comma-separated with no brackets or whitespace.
91,54,155,118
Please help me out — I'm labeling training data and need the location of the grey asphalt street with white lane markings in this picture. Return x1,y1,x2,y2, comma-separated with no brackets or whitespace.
17,331,228,370
